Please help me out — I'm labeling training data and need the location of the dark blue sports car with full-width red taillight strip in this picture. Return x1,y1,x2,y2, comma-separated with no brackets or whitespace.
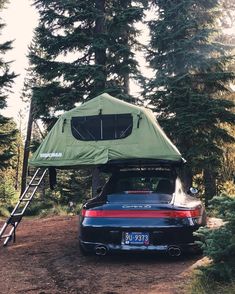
79,167,206,256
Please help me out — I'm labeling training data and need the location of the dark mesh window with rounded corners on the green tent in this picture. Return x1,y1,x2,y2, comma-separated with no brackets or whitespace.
71,113,133,141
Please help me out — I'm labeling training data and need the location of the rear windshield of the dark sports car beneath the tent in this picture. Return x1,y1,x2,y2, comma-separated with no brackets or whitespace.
107,174,175,203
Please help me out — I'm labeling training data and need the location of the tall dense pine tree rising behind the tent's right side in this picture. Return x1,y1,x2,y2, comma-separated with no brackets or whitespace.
146,0,235,204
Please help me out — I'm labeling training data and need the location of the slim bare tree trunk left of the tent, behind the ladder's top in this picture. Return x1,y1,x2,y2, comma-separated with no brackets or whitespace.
21,100,33,195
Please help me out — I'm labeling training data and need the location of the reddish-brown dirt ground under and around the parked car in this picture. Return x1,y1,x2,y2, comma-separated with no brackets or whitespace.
0,216,206,294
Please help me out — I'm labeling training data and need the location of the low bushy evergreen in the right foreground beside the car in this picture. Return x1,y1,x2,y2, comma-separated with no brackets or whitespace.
196,195,235,282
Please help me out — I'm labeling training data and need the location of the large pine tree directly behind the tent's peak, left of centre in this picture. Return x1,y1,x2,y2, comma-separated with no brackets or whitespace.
30,0,146,120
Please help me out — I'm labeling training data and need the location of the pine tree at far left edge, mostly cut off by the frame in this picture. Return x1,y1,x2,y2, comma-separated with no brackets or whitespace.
0,0,16,169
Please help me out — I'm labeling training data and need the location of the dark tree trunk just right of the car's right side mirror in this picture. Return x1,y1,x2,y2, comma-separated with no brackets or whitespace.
203,168,216,207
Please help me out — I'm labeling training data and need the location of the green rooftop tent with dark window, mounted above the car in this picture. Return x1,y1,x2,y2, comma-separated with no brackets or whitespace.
30,94,182,168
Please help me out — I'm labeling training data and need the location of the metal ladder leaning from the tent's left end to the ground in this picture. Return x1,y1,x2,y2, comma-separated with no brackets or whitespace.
0,168,47,246
